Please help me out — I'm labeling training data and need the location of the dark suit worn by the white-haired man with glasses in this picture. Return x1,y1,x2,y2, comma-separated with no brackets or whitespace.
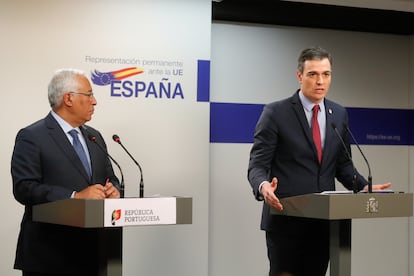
11,113,118,275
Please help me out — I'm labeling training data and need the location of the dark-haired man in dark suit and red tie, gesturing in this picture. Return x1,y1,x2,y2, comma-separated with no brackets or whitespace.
248,47,391,276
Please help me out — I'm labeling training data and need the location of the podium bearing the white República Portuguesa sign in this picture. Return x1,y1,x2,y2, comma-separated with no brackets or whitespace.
33,197,192,276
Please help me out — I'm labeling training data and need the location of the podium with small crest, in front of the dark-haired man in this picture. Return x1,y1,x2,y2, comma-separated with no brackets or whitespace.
271,192,413,276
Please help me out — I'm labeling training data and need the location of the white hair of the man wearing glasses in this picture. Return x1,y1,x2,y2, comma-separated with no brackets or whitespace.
47,68,87,109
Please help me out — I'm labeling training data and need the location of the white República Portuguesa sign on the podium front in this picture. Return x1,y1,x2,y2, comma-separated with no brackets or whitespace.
104,197,176,227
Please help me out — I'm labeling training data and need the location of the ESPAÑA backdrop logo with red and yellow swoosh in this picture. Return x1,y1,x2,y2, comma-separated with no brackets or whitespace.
85,56,184,100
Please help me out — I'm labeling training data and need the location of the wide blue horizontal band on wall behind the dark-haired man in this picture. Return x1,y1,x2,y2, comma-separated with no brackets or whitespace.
210,103,414,145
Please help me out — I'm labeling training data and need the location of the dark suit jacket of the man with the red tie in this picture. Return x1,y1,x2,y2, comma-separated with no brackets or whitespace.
248,91,367,230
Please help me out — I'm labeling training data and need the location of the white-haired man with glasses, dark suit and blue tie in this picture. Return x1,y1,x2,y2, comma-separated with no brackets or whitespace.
11,69,120,276
